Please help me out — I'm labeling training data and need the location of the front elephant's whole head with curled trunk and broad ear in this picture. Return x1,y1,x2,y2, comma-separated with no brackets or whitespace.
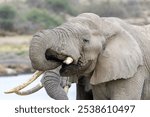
4,13,143,98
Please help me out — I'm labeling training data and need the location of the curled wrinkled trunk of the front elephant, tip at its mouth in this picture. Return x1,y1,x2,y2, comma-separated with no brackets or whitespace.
29,30,61,71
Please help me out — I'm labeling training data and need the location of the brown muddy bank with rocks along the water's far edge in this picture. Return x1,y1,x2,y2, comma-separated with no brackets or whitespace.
0,52,33,76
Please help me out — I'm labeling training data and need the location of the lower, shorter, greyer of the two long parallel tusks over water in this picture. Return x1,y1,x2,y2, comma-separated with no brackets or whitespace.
14,83,43,96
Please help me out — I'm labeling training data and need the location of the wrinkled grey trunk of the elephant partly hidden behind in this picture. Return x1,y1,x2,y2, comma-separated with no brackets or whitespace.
41,68,71,100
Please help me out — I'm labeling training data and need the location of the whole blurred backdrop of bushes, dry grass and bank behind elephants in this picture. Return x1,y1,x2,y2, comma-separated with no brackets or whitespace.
0,0,150,99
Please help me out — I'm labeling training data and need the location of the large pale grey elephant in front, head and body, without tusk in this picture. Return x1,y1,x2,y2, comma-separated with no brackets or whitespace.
29,13,150,100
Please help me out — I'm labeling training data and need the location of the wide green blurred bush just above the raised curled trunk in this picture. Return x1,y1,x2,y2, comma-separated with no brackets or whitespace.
27,8,63,28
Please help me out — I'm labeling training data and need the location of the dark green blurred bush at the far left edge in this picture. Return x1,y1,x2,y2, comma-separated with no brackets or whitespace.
0,4,16,31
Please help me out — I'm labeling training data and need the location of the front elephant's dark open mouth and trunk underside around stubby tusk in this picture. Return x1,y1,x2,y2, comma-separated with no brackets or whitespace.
45,49,91,76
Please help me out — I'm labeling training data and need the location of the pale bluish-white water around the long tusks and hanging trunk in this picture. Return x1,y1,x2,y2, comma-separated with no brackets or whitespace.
0,74,76,100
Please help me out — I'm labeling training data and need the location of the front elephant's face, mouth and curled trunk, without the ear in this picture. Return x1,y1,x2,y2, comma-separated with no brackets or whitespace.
29,14,105,76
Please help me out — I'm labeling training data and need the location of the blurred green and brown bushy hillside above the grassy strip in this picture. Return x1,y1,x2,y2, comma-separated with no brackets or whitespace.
0,0,150,35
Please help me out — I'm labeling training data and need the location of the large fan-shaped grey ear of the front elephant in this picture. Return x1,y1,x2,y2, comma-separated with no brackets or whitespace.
90,30,143,85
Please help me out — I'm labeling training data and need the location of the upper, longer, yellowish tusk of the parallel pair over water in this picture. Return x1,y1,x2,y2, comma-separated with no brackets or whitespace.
5,71,44,94
